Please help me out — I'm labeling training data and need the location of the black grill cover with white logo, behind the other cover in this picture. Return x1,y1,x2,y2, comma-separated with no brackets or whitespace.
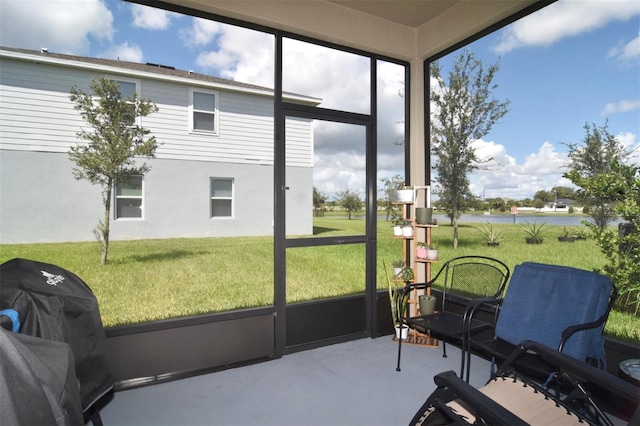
0,259,113,411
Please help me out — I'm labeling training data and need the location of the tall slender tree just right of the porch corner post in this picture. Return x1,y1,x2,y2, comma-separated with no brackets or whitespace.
430,50,509,249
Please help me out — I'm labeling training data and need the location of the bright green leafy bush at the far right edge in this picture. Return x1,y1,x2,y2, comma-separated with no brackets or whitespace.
567,159,640,315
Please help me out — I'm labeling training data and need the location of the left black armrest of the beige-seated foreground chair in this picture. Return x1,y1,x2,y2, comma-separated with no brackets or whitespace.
433,371,527,425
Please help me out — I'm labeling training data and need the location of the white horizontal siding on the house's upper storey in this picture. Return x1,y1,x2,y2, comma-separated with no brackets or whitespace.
0,53,313,167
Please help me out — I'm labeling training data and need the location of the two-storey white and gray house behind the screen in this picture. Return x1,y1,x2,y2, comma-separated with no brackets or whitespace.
0,48,319,244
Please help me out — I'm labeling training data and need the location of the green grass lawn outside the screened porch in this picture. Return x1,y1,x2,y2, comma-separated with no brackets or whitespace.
0,216,640,343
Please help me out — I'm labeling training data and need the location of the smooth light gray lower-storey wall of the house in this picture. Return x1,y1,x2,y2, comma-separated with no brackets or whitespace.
0,151,313,244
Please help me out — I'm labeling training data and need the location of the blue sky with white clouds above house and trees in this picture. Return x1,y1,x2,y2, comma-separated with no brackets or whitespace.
0,0,640,199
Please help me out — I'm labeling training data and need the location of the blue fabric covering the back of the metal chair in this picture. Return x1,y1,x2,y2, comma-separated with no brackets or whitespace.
496,262,613,366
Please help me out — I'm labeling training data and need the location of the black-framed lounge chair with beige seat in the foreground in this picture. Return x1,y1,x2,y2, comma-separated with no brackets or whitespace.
409,341,640,426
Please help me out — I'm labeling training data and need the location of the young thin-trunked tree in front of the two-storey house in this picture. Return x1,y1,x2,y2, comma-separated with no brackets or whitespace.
69,77,158,265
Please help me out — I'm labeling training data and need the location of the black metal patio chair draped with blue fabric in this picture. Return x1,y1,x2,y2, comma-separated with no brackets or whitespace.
467,262,617,379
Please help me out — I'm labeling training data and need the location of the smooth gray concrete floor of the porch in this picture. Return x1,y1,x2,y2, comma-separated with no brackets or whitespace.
95,336,489,425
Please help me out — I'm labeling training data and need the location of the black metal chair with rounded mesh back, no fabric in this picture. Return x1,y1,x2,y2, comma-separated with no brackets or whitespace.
396,256,510,376
